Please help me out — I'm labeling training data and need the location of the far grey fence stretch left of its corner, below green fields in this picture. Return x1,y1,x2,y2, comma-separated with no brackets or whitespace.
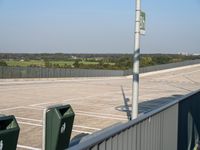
0,67,124,78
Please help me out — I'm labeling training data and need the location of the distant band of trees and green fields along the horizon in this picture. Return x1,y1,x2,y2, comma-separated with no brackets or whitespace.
0,53,200,70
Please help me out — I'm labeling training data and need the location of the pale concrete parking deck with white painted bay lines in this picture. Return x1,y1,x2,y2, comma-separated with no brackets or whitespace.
0,64,200,150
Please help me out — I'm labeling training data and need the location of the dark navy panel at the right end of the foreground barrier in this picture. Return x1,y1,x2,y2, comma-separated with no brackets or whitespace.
178,92,200,150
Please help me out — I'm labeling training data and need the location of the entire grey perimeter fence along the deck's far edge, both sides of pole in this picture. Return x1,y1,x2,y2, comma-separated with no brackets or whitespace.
0,59,200,79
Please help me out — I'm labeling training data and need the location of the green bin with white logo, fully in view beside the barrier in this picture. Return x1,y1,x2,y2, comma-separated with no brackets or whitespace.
43,105,75,150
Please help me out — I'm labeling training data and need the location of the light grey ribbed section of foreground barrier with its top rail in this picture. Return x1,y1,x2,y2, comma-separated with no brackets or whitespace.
69,103,178,150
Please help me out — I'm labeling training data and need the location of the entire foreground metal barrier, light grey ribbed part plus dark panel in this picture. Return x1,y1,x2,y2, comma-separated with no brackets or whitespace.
69,91,200,150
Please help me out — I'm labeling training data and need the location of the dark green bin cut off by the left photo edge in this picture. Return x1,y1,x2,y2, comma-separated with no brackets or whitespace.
0,115,20,150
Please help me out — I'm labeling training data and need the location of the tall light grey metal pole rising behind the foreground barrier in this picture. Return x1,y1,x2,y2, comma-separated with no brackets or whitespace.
132,0,141,119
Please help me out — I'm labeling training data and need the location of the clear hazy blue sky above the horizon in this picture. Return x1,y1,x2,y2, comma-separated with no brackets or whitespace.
0,0,200,53
